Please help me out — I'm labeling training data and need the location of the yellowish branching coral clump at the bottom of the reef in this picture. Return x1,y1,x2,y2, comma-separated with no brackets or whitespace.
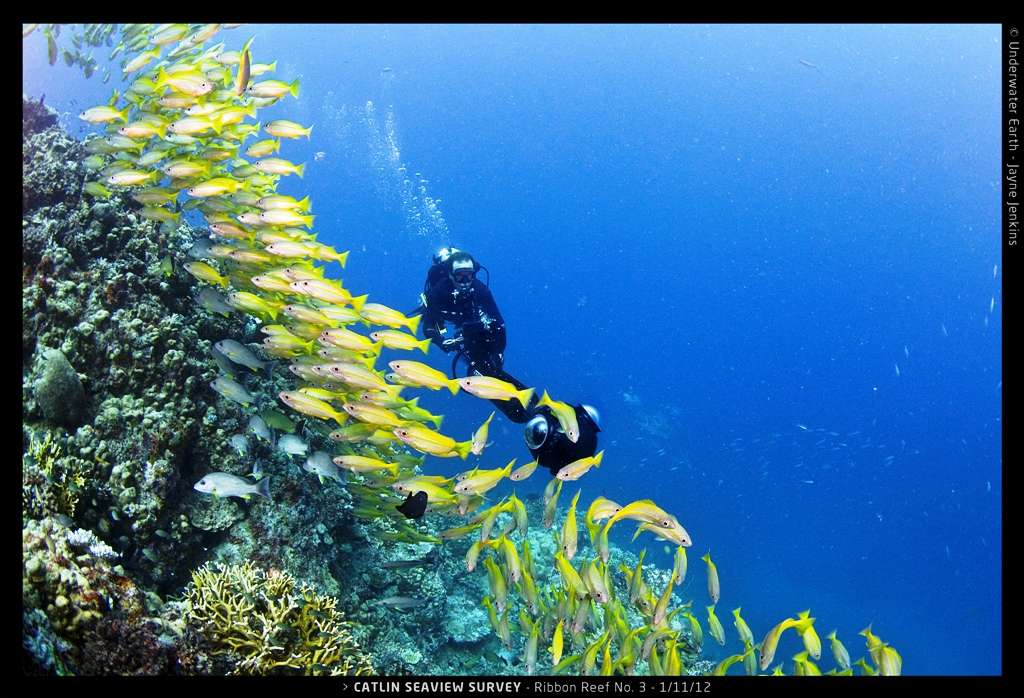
184,561,374,675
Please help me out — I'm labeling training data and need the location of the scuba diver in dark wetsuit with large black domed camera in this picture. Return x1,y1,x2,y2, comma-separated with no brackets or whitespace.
410,248,601,475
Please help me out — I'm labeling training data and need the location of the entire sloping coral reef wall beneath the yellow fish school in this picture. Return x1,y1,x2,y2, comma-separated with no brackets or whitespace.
23,81,712,674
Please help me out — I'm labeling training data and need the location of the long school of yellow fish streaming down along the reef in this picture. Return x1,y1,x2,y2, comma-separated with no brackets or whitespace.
68,24,902,675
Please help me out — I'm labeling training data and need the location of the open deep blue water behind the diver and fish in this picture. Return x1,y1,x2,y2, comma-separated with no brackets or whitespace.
24,25,1002,674
